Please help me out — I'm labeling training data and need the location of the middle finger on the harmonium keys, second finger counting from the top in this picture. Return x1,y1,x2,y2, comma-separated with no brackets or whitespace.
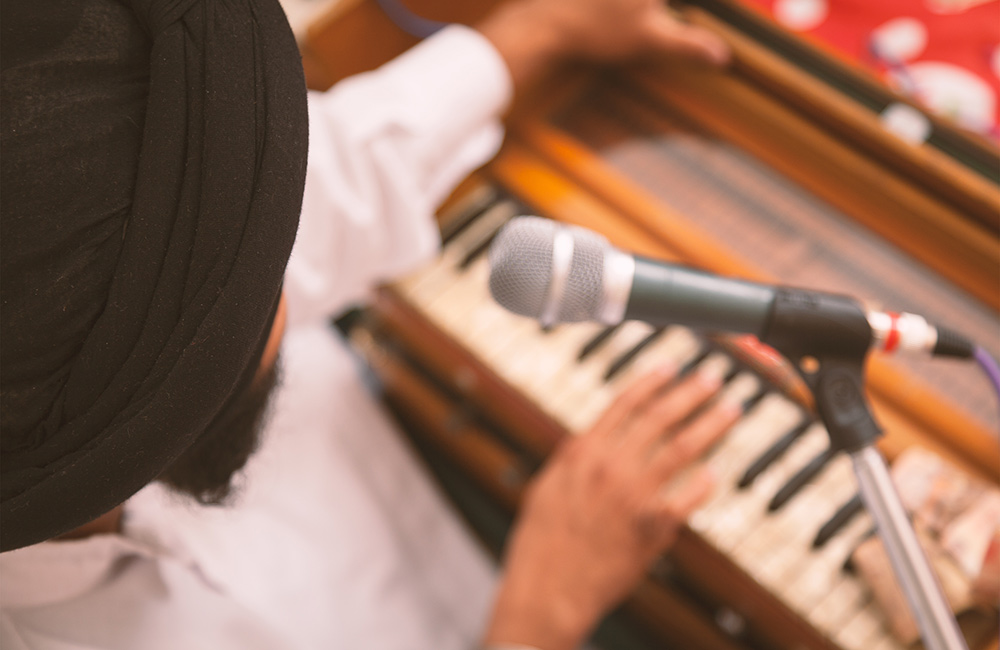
622,363,724,458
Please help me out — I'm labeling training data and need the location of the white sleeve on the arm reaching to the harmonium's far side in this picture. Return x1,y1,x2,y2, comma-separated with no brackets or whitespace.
285,25,513,325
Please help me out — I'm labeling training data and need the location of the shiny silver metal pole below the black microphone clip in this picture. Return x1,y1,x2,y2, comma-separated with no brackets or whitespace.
851,446,968,650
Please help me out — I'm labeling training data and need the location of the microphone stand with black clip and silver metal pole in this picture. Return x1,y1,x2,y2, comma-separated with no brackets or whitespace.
760,288,968,650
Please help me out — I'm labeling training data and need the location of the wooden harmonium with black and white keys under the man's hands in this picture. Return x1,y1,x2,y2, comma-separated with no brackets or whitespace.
300,0,1000,650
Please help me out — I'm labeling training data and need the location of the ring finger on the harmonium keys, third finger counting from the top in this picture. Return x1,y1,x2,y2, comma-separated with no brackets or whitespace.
646,398,743,484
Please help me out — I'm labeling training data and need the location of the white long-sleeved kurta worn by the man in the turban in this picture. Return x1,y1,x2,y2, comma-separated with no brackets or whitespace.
0,27,511,650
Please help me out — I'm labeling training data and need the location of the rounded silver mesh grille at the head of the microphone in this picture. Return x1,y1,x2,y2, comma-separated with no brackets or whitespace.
489,217,610,322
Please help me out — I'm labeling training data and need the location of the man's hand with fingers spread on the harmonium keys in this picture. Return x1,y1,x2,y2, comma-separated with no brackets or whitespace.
486,360,742,650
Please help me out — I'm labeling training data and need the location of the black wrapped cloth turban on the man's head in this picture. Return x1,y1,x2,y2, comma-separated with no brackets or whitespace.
0,0,307,550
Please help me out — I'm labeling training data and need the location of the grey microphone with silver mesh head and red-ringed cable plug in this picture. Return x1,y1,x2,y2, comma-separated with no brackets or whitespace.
489,216,975,358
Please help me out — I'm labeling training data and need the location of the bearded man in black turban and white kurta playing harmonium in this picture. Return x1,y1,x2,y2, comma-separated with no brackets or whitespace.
0,0,738,650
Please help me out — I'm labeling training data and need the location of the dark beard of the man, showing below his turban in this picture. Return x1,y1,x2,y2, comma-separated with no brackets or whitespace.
157,360,280,505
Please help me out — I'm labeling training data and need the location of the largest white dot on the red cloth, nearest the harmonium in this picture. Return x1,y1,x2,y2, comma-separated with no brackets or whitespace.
890,61,997,133
